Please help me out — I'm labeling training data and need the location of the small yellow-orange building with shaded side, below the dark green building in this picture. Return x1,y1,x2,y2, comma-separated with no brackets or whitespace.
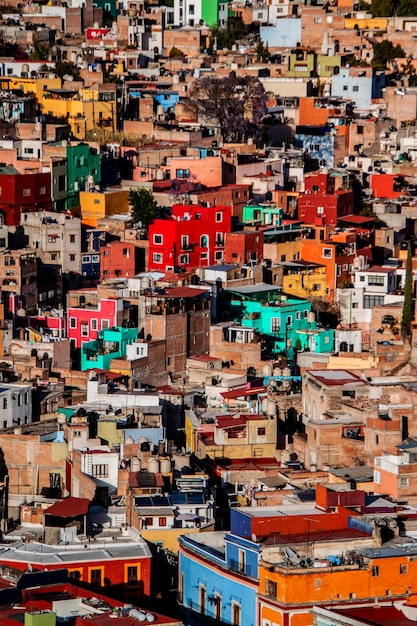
80,189,129,228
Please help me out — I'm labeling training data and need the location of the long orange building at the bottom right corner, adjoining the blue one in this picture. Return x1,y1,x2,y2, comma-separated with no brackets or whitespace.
258,540,417,626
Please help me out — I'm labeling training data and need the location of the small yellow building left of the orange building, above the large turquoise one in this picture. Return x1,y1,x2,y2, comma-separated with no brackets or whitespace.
282,261,327,298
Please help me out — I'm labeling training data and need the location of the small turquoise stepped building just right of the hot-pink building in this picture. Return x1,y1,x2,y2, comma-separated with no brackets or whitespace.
81,326,138,372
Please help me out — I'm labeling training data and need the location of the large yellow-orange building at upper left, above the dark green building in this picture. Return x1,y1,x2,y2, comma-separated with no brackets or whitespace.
41,84,117,139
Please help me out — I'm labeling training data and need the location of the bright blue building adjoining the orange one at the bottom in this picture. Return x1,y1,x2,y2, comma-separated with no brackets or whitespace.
179,532,260,626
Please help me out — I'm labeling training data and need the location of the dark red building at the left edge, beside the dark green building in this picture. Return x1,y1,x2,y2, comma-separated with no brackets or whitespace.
0,167,52,226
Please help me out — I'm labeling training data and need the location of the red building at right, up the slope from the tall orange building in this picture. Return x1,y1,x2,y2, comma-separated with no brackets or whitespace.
298,174,353,225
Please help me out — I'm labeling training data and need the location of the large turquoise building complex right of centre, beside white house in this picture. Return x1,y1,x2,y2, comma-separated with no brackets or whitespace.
225,284,334,359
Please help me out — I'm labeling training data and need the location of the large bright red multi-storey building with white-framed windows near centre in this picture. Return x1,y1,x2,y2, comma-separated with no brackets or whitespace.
148,204,232,271
